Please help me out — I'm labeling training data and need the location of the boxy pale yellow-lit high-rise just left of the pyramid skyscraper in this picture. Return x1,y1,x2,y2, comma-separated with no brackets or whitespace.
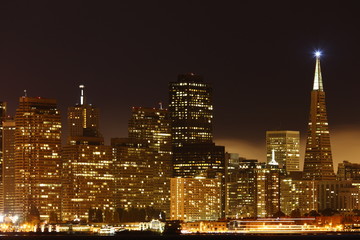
266,131,300,172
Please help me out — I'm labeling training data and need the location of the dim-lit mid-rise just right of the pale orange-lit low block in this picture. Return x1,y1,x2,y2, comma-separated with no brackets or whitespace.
225,154,259,218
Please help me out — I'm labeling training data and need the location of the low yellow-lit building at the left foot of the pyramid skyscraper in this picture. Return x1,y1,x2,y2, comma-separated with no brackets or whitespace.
280,178,318,216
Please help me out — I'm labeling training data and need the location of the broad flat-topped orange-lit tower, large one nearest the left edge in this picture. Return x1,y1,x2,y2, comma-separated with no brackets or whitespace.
14,96,61,220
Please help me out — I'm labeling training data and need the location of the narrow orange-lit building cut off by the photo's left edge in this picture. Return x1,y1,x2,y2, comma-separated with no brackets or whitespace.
2,119,15,215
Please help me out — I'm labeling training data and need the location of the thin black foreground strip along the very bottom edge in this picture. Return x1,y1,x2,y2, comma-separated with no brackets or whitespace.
0,233,360,240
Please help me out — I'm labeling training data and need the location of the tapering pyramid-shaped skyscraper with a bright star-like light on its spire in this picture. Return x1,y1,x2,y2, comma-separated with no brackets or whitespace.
304,52,335,180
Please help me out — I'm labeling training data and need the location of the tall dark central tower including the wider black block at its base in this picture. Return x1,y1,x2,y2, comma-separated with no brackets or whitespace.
169,73,225,177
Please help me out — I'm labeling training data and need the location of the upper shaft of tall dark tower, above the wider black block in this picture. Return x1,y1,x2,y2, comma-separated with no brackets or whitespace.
169,73,213,147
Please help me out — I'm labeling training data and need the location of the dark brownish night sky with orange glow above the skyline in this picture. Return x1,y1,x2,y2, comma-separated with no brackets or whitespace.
0,0,360,168
